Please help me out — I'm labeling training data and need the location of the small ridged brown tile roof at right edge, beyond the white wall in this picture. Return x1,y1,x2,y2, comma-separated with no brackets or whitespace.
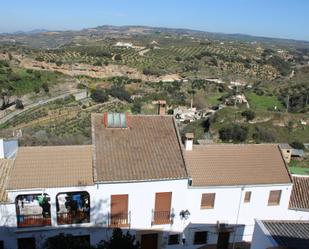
289,176,309,210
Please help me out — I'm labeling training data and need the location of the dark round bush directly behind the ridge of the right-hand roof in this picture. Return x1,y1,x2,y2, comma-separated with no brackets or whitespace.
219,124,248,142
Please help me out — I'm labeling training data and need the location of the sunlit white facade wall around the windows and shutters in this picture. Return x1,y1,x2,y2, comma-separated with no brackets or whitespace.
0,179,300,249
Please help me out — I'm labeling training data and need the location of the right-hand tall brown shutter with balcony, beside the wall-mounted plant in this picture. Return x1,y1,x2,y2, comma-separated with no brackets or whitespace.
154,192,172,224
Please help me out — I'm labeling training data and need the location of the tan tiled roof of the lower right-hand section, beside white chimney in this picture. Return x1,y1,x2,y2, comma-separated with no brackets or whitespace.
184,144,291,186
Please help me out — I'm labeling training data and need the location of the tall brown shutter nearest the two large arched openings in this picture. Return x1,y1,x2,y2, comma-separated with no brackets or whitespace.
111,195,129,226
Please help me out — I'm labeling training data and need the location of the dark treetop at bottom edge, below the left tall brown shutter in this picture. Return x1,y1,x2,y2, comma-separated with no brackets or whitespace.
97,228,140,249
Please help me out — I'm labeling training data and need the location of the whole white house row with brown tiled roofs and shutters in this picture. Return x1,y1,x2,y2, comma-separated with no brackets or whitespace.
0,113,306,249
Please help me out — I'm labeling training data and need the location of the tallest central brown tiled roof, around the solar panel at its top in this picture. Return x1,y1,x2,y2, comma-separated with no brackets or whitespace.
92,114,187,182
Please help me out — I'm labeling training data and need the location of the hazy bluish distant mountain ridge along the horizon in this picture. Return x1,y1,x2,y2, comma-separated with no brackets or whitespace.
0,25,309,48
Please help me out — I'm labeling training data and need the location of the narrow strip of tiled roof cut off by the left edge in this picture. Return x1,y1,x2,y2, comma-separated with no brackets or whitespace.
0,159,14,202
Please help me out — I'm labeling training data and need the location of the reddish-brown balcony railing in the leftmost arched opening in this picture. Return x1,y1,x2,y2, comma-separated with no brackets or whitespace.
17,214,51,228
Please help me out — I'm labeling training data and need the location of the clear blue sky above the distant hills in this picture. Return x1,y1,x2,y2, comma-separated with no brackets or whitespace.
0,0,309,40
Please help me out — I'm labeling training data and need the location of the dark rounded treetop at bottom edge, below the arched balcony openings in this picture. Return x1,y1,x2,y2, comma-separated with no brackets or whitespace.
43,233,95,249
